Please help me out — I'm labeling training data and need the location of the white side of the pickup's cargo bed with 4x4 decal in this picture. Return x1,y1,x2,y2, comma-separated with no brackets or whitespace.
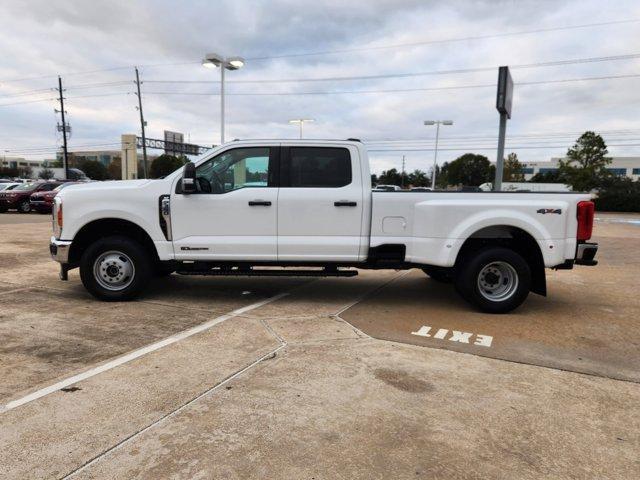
370,191,590,267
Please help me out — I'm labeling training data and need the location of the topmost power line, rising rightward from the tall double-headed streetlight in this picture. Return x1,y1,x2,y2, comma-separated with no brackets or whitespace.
246,18,640,61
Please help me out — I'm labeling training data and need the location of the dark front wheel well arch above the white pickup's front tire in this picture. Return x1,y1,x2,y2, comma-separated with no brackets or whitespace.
69,218,159,265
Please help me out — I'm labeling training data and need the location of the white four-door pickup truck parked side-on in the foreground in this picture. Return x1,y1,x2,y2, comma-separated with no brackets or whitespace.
50,139,598,313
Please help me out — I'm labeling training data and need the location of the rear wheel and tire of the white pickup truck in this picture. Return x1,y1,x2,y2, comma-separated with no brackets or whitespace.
455,247,531,313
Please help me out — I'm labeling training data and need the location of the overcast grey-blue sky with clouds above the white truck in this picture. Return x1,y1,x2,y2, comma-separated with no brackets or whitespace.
0,0,640,172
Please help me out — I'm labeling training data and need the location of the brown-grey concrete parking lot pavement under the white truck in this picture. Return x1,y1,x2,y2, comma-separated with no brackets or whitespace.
0,213,640,479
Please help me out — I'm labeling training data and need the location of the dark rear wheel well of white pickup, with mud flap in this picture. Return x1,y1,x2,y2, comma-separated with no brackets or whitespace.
456,225,547,295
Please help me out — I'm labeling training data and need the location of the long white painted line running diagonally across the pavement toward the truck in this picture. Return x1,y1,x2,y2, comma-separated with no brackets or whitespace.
0,293,289,413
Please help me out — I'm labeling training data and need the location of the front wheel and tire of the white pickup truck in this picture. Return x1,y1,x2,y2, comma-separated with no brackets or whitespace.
80,236,152,302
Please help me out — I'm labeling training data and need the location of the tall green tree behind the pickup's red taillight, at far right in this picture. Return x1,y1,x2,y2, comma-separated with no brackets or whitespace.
558,131,611,191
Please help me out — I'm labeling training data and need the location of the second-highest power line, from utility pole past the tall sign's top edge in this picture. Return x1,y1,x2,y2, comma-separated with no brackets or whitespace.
145,53,640,84
